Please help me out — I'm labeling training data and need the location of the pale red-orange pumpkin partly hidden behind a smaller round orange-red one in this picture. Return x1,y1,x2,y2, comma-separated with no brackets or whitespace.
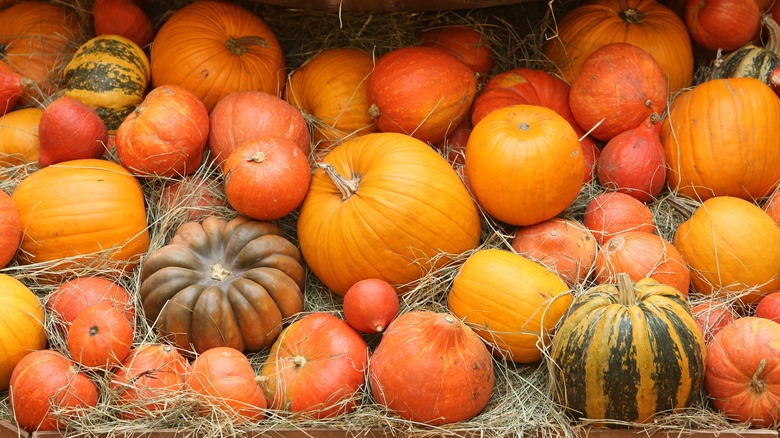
208,91,311,165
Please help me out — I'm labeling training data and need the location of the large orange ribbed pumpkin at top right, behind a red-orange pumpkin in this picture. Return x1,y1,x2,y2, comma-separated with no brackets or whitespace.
544,0,693,93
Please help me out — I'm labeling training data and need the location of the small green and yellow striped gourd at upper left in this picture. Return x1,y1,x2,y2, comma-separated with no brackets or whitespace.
64,35,150,133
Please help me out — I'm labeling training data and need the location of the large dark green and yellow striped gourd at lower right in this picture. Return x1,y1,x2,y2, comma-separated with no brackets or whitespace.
551,273,706,424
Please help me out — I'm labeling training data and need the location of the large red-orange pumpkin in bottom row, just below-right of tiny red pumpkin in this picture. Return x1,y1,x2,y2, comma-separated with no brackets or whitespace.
368,310,495,425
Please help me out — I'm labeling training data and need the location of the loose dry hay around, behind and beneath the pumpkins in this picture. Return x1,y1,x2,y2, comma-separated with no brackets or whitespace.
0,0,760,437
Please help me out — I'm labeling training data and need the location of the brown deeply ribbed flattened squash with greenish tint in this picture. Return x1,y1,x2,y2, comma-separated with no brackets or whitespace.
138,216,305,353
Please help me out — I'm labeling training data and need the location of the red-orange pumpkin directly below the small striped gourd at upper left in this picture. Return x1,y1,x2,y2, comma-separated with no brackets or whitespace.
115,85,209,176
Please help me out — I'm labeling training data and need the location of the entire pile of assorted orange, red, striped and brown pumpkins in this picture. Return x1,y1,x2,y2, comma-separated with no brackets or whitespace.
0,0,780,431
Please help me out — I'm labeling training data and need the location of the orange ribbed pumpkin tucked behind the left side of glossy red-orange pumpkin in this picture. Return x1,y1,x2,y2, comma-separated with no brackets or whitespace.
285,48,377,155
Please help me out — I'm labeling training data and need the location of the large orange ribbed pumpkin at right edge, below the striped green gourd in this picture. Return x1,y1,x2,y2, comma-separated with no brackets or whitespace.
661,78,780,200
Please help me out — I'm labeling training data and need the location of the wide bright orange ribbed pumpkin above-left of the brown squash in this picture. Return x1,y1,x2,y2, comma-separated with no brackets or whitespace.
11,159,149,269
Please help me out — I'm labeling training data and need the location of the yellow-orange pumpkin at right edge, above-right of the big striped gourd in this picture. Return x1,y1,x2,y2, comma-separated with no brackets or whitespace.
674,196,780,304
